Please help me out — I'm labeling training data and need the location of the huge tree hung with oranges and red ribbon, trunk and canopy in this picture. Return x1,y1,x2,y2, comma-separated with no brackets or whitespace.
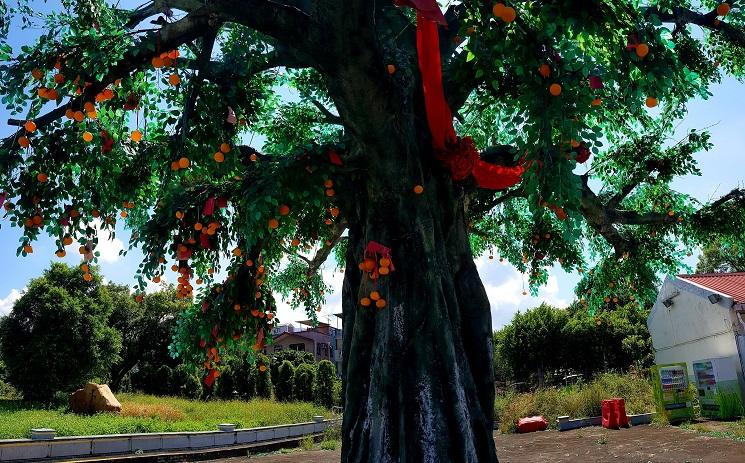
0,0,745,462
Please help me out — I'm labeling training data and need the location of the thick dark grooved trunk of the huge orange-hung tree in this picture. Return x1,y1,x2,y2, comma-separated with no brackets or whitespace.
328,38,497,463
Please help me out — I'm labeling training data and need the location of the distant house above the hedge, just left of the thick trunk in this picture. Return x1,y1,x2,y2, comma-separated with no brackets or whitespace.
264,320,342,374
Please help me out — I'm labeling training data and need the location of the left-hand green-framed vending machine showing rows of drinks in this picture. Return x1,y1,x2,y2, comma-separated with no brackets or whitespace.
652,362,693,423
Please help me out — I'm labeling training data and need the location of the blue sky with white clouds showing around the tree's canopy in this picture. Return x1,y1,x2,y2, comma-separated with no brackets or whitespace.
0,0,745,328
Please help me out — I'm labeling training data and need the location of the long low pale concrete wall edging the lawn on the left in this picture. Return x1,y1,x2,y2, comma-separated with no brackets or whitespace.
0,420,339,461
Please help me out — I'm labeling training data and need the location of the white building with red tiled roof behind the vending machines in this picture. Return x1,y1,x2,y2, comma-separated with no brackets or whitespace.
647,273,745,391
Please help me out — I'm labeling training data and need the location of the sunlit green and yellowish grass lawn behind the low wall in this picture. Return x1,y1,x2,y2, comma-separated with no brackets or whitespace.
0,394,331,439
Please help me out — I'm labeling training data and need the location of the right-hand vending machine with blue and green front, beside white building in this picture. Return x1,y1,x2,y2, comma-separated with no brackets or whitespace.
693,357,743,420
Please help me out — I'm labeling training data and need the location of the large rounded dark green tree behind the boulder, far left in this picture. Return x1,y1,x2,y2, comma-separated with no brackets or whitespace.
0,264,121,401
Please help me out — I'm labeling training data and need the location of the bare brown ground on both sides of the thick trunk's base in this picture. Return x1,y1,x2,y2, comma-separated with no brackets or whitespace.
208,426,745,463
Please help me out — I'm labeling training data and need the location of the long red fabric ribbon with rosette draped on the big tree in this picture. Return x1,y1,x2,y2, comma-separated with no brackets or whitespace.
395,0,524,190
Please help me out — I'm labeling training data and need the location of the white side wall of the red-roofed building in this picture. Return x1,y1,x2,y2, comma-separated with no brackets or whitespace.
647,277,745,396
